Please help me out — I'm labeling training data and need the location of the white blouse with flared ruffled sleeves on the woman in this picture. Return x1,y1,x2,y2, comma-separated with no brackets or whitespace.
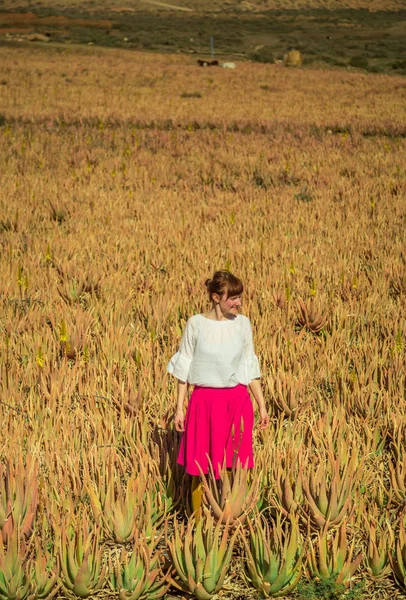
168,315,260,388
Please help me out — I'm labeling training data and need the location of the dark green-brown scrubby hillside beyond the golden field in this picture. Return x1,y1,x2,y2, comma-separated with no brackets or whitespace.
0,0,406,74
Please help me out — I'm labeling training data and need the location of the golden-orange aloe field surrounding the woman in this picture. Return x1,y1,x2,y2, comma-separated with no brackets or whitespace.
0,45,406,600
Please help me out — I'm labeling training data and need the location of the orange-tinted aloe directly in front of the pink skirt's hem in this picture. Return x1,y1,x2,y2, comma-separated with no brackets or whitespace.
199,461,261,525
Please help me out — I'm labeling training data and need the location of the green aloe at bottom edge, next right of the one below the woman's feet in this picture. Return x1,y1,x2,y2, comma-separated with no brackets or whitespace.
241,515,304,598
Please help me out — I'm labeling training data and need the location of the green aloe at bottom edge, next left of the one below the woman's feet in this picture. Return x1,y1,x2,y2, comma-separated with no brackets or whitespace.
109,530,170,600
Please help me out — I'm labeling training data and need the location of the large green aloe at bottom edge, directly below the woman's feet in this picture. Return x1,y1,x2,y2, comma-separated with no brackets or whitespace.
168,510,238,600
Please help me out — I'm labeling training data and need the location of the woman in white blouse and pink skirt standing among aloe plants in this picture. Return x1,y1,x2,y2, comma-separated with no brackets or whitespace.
168,271,269,511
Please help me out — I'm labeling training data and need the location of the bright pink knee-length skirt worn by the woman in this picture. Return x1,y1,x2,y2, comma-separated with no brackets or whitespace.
178,384,254,478
